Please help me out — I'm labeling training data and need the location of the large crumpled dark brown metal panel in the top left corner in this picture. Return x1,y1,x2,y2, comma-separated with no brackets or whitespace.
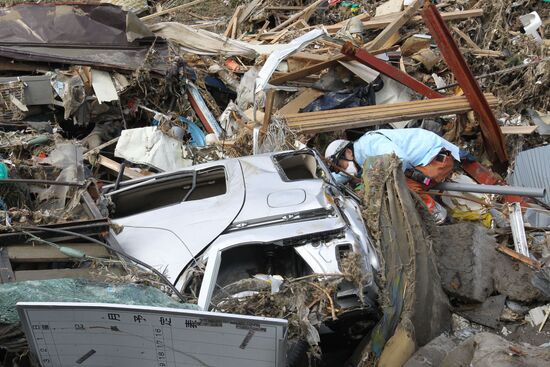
0,4,167,73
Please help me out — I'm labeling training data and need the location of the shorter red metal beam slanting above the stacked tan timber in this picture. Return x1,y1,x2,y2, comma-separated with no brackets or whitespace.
342,42,443,99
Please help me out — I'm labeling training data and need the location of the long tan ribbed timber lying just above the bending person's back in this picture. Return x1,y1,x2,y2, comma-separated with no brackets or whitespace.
285,94,498,133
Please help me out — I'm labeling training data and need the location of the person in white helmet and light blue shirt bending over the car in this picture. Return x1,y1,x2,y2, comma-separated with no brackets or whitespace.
325,129,461,222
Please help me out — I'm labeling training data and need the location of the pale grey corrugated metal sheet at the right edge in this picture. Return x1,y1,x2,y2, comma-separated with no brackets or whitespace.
508,145,550,205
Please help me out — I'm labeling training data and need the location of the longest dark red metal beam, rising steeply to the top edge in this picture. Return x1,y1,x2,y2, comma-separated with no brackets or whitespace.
422,0,508,165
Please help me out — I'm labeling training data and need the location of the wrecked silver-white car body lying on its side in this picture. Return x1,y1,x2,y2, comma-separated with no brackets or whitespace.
105,150,379,338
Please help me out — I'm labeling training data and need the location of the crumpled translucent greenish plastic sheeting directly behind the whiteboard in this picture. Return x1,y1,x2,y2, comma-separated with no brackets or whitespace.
0,279,198,323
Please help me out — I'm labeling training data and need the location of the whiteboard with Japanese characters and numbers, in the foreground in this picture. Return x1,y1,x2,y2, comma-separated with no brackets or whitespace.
17,302,287,367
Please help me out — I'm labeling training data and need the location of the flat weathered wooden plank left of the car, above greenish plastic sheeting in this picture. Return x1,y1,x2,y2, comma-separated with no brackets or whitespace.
6,243,110,263
